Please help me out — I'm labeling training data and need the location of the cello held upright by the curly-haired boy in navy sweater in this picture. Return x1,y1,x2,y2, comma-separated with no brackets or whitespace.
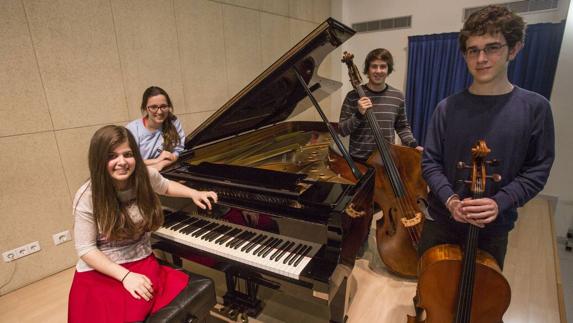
408,140,511,323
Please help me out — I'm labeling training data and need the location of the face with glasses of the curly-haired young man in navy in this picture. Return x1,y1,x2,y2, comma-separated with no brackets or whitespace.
464,33,520,85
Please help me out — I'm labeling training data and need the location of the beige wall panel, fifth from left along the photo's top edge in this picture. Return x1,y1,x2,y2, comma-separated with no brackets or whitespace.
223,5,263,97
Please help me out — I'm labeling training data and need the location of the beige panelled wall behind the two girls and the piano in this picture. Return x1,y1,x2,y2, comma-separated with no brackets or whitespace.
0,0,331,295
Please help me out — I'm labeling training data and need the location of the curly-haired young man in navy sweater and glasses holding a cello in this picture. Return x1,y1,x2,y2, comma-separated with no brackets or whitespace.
418,6,555,268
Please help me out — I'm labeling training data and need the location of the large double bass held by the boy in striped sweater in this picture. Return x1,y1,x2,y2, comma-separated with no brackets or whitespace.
342,52,428,278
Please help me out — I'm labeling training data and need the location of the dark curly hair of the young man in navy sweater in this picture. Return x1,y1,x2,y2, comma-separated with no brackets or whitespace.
459,5,525,53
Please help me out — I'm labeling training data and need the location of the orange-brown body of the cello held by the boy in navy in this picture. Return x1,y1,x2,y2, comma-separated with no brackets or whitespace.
408,244,511,323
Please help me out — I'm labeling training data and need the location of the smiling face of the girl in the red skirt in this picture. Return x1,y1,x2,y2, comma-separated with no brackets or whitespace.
107,141,135,190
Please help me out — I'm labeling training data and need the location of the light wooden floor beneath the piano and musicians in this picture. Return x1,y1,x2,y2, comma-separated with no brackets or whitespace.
0,199,566,323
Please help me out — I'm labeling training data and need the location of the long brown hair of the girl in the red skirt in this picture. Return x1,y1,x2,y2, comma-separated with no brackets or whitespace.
88,125,163,240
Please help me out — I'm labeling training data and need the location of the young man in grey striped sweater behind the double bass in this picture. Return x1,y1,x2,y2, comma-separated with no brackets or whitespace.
338,48,422,162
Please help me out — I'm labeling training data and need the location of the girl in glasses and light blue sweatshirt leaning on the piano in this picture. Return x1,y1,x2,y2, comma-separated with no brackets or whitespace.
126,86,185,170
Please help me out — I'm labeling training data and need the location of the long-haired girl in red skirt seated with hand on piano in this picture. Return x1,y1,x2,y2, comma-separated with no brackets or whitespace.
68,126,217,323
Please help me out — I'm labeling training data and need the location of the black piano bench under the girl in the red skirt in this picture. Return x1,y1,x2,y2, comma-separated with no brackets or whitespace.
145,264,217,323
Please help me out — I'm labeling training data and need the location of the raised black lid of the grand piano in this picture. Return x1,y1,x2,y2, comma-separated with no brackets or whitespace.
185,18,355,149
